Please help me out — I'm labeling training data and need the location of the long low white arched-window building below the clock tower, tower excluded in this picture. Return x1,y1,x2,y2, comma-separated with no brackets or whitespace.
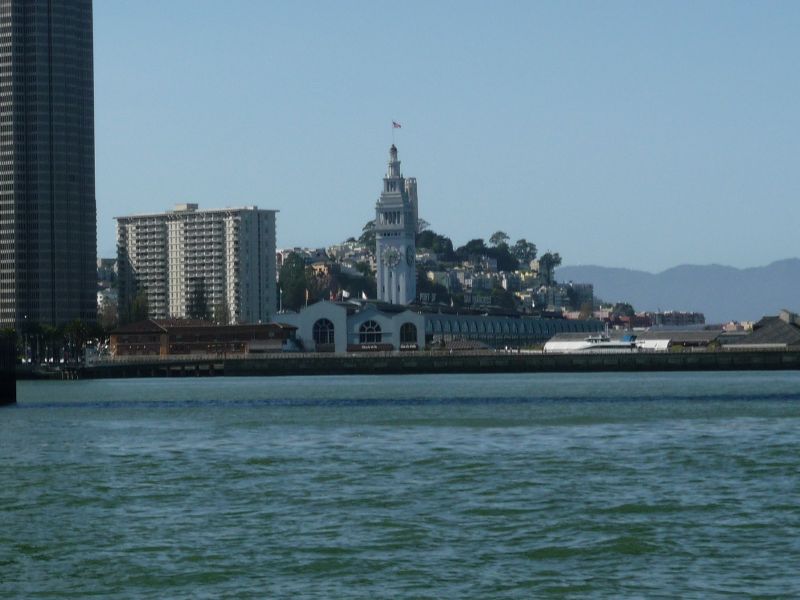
276,301,604,353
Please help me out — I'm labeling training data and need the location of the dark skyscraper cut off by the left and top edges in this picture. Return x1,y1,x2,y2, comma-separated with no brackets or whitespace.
0,0,97,327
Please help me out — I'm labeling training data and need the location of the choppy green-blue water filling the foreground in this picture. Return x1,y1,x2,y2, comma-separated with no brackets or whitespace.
0,373,800,598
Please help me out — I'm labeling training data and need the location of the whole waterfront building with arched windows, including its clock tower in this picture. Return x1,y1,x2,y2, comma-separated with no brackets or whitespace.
275,144,603,353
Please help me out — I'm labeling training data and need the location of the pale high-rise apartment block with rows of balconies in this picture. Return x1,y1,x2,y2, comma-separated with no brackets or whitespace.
117,204,277,323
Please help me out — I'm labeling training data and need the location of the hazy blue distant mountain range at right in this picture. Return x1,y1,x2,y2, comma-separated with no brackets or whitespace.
556,258,800,323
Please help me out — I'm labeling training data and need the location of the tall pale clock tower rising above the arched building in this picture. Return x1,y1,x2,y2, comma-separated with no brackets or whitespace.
375,144,417,304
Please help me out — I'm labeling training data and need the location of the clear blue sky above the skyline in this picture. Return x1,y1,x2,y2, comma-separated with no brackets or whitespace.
94,0,800,271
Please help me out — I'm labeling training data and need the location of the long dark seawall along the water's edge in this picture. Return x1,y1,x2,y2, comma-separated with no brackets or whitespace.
66,351,800,378
